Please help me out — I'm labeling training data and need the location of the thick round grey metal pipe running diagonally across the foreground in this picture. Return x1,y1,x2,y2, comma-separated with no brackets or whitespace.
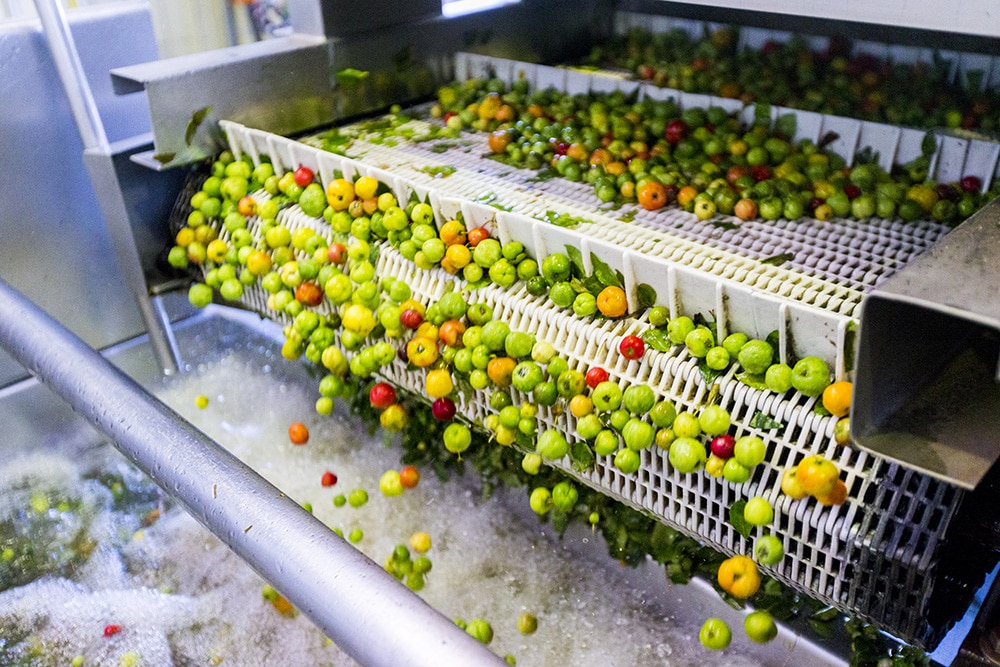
0,280,506,667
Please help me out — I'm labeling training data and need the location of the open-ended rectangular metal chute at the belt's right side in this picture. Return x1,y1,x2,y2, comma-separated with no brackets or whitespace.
851,202,1000,489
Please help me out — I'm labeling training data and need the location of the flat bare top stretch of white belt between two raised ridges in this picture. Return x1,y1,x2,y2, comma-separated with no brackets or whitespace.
318,121,947,302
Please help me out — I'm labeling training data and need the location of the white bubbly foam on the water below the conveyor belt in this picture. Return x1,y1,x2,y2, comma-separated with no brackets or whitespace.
0,358,759,667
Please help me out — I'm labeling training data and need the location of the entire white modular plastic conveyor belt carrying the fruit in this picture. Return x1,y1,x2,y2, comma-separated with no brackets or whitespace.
209,54,995,644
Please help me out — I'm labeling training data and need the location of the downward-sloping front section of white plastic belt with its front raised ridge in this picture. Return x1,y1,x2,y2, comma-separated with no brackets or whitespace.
222,123,960,643
